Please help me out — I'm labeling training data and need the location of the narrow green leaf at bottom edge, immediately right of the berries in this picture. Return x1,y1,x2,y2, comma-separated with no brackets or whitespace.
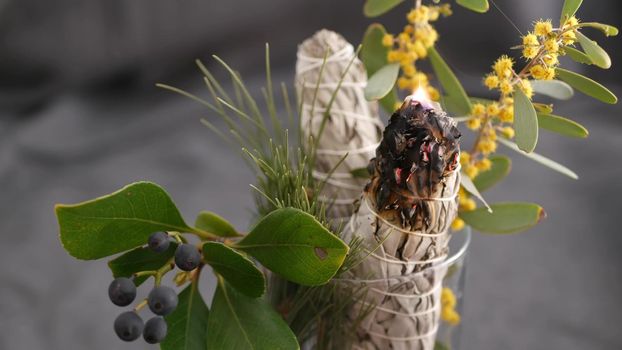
160,282,209,350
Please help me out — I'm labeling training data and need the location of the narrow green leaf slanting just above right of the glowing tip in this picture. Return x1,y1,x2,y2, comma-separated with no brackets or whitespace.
428,47,472,116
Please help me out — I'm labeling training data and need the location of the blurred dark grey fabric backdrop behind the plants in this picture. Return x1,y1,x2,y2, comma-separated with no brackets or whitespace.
0,0,622,350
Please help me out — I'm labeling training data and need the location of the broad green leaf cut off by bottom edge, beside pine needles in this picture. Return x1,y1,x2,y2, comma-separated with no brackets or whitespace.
204,280,300,350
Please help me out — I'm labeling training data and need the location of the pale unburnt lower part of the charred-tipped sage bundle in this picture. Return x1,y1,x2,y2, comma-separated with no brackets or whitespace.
342,152,460,350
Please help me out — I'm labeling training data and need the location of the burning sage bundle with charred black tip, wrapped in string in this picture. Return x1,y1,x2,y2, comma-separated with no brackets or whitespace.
337,97,460,350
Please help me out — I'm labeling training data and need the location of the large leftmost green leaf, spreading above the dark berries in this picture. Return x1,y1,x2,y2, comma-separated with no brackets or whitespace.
55,182,199,260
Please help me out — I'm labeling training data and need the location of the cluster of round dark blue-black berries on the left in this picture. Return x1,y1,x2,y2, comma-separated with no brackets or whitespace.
108,232,201,344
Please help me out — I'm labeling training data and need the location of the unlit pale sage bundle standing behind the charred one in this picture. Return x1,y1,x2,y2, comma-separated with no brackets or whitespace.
296,29,384,226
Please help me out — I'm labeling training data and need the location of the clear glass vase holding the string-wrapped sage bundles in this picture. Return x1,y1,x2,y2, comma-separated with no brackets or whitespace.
301,228,471,350
